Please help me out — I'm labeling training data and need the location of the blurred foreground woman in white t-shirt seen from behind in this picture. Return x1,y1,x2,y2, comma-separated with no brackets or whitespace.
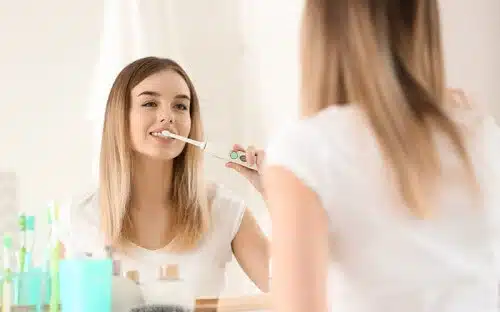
263,0,500,312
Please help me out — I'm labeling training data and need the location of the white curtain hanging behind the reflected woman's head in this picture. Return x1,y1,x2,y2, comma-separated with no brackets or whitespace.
88,0,181,177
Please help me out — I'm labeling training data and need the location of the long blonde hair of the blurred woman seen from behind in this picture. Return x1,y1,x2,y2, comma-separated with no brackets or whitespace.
301,0,473,216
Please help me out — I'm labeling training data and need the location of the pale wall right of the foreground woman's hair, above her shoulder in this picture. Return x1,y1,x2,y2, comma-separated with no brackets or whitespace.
441,0,500,118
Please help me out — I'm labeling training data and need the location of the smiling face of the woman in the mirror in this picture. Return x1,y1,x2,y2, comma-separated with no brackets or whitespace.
129,70,191,160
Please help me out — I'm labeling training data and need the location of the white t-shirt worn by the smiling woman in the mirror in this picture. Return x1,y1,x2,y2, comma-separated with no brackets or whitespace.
61,185,245,303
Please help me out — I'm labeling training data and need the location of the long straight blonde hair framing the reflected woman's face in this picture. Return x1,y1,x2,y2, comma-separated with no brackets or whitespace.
99,57,209,250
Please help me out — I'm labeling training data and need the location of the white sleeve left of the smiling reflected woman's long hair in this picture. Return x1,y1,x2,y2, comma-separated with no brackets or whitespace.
58,192,102,255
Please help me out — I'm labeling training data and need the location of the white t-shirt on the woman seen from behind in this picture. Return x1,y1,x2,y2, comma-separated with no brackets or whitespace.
266,105,500,312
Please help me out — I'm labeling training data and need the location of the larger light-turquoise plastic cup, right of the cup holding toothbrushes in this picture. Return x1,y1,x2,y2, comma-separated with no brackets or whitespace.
59,259,113,312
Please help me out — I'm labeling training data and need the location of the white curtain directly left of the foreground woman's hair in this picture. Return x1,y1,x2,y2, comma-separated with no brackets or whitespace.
242,0,303,138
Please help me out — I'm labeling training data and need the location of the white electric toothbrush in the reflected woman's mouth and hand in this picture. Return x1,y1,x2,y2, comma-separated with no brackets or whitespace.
160,130,257,170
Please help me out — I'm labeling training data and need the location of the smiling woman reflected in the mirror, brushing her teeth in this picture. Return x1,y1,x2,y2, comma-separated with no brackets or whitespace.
62,57,268,299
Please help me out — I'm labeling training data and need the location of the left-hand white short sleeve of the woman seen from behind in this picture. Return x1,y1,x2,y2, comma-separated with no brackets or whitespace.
265,121,332,204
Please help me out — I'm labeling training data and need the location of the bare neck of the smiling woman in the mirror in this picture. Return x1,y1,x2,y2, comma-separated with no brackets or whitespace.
131,156,173,210
